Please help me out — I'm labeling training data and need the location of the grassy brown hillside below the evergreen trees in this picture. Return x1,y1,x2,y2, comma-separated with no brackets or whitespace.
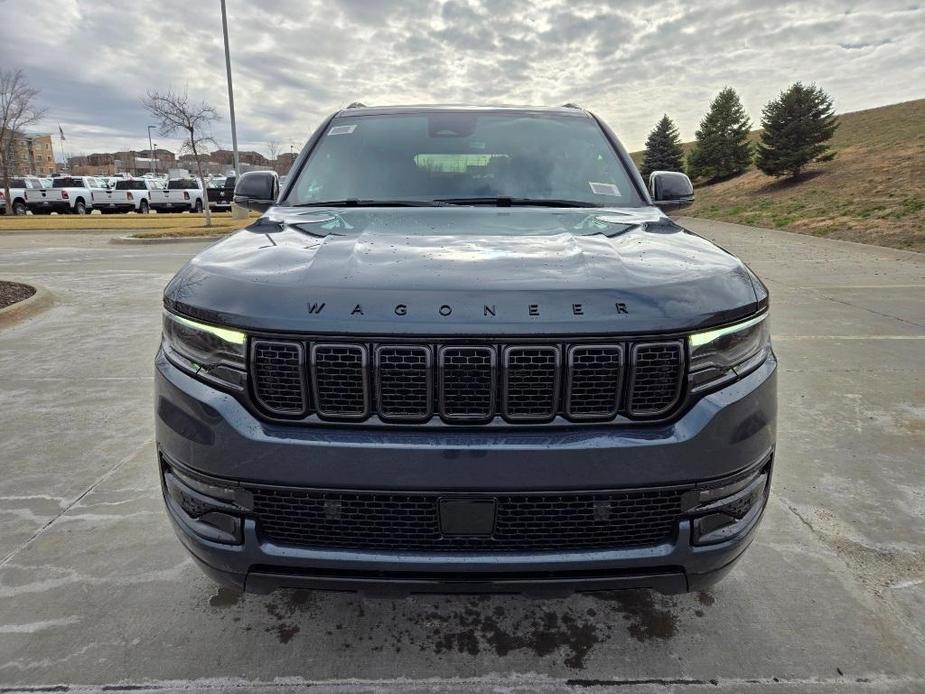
633,99,925,252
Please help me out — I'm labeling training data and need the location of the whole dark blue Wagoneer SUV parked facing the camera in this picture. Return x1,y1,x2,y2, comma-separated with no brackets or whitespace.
156,106,777,594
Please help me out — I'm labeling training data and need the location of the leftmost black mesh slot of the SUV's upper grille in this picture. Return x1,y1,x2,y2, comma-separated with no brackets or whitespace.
253,340,306,415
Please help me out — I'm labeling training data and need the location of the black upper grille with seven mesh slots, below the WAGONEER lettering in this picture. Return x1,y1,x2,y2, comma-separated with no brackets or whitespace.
251,338,685,424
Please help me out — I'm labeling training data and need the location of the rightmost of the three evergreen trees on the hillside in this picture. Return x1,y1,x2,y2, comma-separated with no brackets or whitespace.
755,82,838,177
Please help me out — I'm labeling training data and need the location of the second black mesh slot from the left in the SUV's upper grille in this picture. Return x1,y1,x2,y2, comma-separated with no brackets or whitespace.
311,343,369,419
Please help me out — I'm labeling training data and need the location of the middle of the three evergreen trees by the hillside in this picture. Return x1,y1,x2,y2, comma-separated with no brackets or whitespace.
687,87,752,180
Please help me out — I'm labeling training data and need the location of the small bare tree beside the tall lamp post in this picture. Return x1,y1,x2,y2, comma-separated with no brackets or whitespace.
141,89,219,227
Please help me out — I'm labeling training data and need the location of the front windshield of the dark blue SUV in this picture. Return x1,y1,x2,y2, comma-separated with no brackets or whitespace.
283,111,642,207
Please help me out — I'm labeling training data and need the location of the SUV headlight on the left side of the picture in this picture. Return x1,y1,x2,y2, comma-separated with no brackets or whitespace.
163,311,247,390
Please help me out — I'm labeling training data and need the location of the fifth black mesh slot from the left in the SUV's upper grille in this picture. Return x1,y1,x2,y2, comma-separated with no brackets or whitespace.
501,345,560,421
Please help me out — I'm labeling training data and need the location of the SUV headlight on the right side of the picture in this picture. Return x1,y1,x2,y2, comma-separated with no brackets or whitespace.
687,313,771,393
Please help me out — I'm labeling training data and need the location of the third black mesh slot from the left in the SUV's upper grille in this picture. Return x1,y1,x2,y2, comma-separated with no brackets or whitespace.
376,345,434,421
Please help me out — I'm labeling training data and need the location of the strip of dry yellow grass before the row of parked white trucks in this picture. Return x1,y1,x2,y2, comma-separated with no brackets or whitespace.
0,212,259,235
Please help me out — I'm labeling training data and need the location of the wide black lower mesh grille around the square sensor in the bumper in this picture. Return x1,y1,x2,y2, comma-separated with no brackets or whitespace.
251,488,684,551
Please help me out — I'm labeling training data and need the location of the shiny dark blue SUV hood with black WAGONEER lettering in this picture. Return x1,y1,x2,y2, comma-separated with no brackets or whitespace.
165,207,757,335
